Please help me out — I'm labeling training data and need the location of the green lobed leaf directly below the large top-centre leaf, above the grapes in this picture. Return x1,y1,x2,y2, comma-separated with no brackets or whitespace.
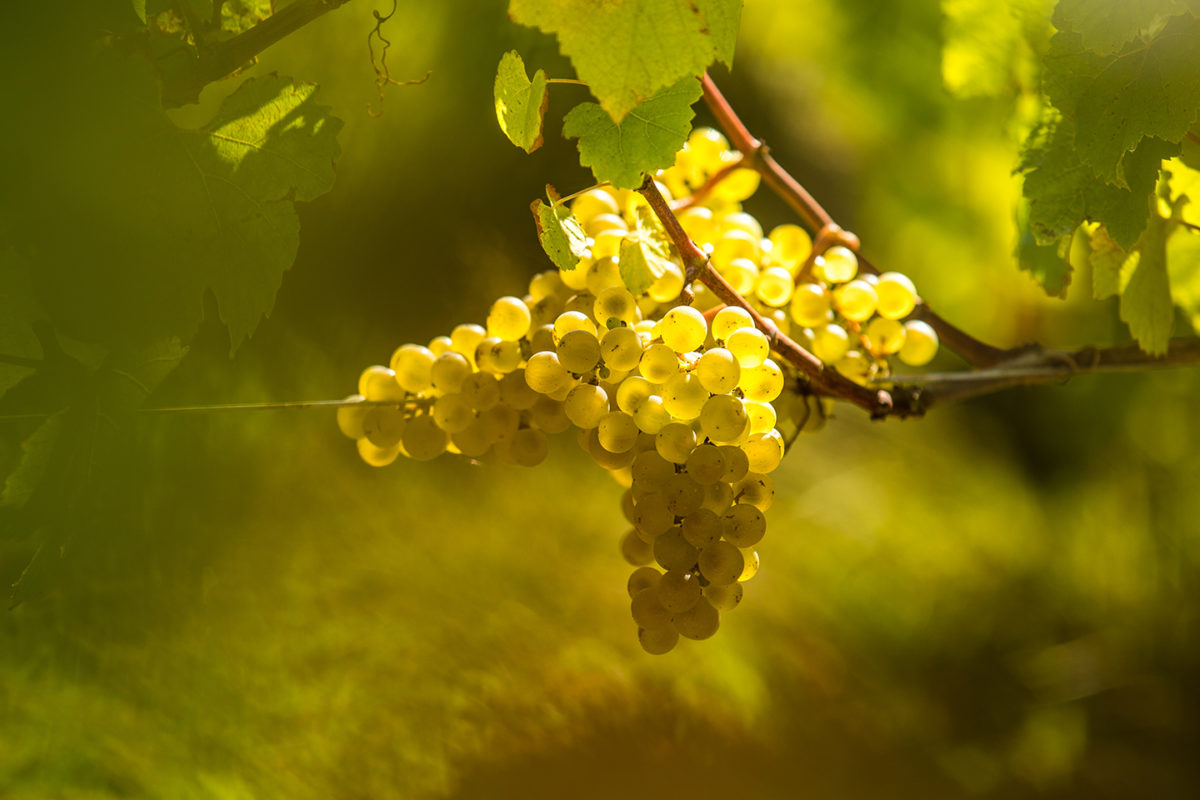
563,78,701,188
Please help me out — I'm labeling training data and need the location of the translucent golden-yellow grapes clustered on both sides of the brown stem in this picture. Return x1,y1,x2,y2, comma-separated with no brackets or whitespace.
337,123,937,654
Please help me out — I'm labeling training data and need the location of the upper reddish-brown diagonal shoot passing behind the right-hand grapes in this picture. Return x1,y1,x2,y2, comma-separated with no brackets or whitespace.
701,73,1025,367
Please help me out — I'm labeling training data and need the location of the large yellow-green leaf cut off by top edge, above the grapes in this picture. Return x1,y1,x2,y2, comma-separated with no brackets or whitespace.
509,0,742,122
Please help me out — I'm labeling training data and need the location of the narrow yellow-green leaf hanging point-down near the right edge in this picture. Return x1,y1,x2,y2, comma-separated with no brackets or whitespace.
1121,216,1175,355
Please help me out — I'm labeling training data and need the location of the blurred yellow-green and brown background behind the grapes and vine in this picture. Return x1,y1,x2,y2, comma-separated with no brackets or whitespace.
0,0,1200,800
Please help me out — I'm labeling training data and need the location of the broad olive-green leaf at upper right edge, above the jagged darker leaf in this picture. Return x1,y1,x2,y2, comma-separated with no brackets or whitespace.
1045,14,1200,187
